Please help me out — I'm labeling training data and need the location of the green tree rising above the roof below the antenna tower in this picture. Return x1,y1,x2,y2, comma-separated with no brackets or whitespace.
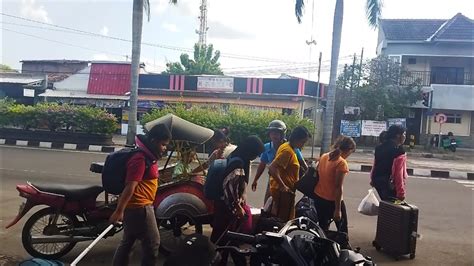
163,44,223,75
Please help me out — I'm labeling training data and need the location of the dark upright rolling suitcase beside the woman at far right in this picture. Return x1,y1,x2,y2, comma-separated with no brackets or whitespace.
372,201,418,259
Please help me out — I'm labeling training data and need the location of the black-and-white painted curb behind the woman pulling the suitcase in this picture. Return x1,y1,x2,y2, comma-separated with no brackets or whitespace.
349,163,474,180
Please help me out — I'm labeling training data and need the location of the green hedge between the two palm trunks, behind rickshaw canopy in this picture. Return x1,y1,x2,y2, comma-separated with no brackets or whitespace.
141,103,313,144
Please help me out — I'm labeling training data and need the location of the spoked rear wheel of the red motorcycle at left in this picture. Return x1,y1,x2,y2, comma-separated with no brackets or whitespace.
21,208,79,259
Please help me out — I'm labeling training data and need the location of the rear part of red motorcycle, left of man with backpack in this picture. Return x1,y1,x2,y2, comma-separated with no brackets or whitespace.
6,182,123,259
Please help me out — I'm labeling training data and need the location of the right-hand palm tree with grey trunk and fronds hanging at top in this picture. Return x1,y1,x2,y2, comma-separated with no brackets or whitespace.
295,0,382,154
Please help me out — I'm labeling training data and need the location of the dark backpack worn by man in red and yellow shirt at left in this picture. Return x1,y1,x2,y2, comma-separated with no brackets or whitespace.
102,147,152,195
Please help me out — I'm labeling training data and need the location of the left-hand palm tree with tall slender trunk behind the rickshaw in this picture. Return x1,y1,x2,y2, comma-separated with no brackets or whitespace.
127,0,178,145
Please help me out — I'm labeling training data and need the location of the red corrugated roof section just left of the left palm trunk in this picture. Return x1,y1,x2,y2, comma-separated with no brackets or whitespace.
87,63,131,95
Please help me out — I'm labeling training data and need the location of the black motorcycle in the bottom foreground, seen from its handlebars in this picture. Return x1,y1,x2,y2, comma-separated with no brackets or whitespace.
217,217,375,266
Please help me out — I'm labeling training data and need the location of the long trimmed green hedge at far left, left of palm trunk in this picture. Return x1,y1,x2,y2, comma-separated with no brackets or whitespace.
0,99,118,134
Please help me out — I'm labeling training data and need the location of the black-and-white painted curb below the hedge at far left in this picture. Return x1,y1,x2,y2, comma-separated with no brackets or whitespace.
0,139,118,153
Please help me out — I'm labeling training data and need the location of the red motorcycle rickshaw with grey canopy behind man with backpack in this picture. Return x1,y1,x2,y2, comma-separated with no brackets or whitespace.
7,115,220,259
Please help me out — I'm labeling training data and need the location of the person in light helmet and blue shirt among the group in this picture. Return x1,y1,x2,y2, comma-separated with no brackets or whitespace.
248,120,307,204
